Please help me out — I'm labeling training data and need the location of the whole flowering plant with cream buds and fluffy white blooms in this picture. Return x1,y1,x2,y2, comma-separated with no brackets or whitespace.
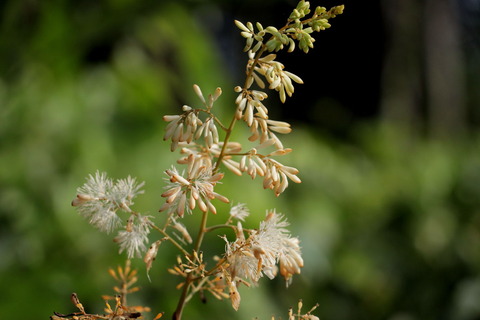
52,0,343,319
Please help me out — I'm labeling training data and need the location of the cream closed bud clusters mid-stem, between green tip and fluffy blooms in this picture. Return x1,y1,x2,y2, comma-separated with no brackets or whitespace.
160,71,301,196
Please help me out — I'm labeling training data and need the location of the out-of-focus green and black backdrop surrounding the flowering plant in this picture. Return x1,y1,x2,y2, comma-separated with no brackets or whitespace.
0,0,480,320
